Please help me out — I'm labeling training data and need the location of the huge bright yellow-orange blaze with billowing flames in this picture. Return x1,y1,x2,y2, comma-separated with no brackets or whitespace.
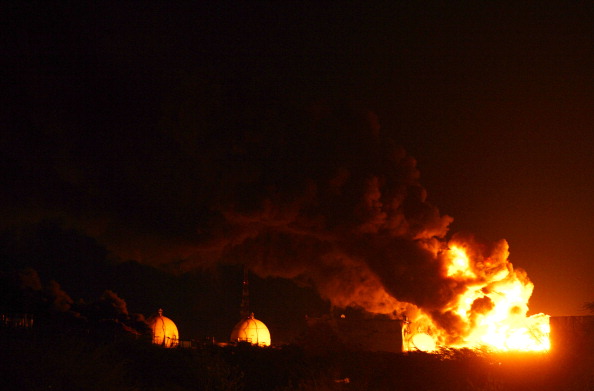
405,240,550,351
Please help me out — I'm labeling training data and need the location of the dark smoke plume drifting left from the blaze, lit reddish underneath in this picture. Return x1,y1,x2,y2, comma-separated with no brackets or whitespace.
3,97,456,313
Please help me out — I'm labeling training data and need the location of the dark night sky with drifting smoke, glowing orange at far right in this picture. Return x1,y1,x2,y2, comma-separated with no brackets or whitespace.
0,2,594,338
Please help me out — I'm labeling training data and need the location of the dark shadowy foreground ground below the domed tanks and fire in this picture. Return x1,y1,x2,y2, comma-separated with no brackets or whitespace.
0,328,594,391
